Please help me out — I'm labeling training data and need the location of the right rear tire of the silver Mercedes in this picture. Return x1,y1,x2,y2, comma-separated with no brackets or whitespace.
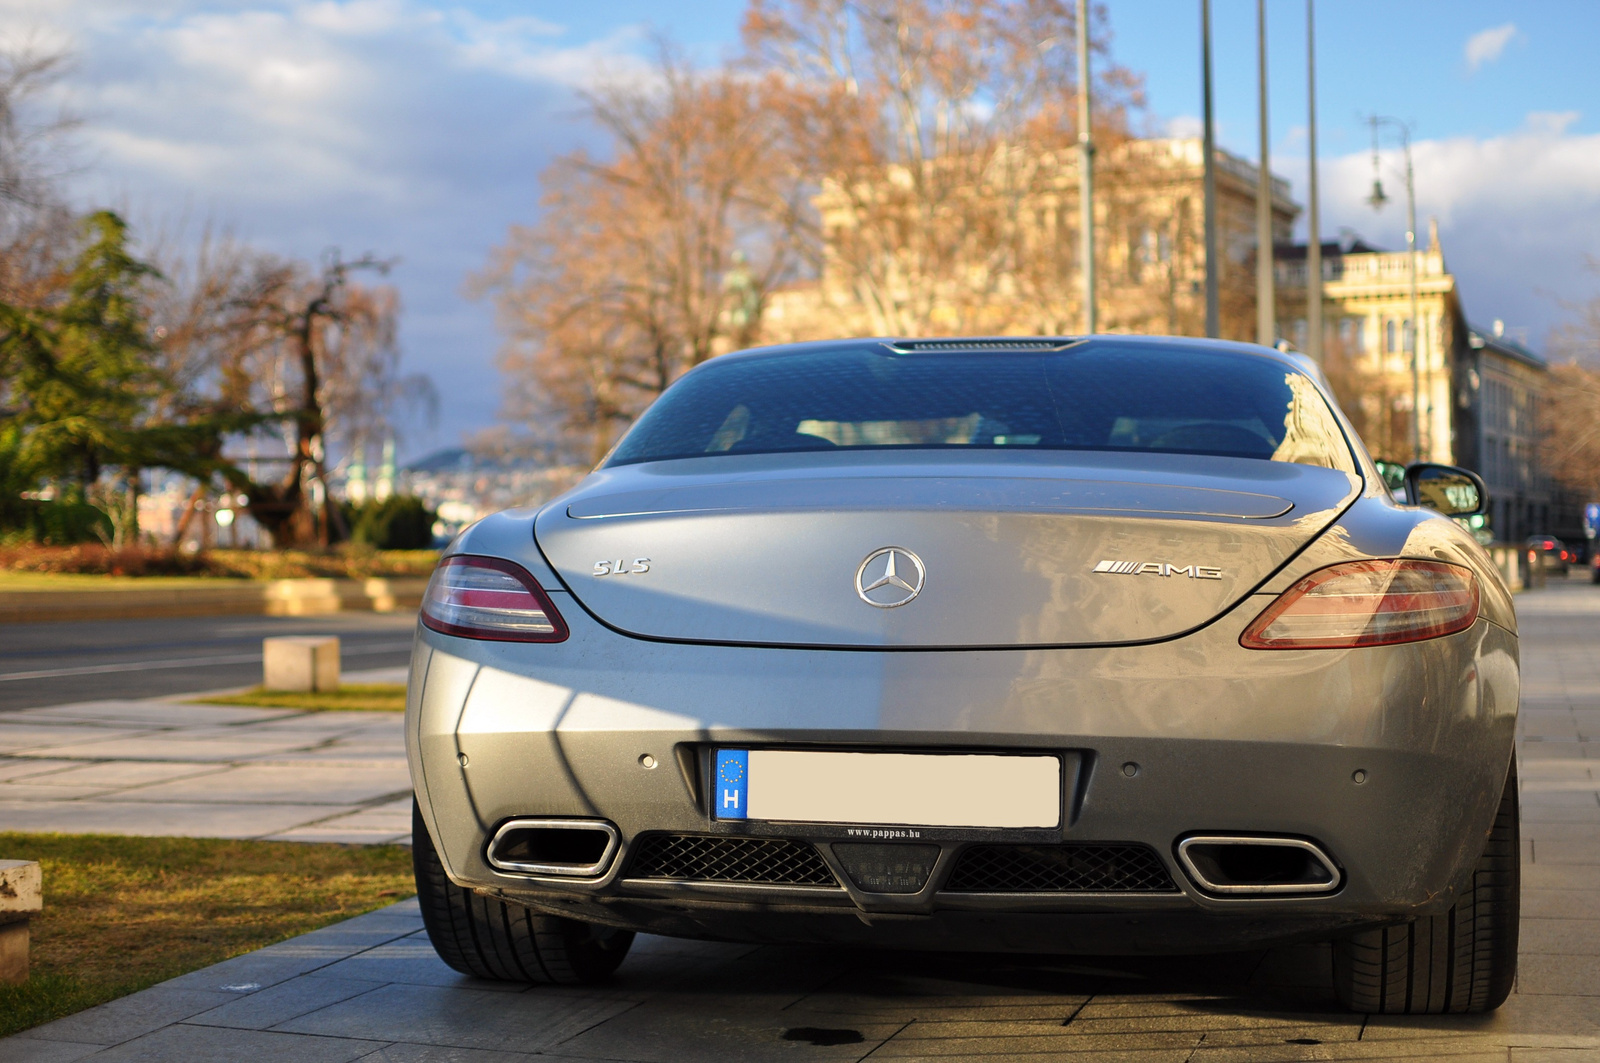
1333,762,1522,1015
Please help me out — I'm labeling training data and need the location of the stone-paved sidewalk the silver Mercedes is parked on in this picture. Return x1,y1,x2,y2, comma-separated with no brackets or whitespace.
0,583,1600,1063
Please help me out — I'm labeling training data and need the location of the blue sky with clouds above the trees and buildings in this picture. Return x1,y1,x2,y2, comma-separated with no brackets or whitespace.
12,0,1600,455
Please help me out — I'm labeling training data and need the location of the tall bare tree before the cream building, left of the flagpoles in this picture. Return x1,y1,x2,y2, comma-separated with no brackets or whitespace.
744,0,1142,335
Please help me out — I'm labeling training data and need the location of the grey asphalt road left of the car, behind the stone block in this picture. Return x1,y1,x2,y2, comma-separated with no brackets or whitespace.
0,612,416,712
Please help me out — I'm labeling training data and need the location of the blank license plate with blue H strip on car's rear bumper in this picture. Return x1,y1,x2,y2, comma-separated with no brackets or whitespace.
712,749,1061,828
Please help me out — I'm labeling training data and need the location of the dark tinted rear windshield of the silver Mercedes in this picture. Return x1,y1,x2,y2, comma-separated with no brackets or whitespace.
608,343,1354,469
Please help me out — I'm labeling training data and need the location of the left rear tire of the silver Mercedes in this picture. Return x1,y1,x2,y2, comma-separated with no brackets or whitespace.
411,799,634,986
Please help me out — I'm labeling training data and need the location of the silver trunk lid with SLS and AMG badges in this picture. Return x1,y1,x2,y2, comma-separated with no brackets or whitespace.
534,451,1360,648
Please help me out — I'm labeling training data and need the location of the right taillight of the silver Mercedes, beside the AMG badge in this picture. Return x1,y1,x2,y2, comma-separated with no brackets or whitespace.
1238,559,1478,650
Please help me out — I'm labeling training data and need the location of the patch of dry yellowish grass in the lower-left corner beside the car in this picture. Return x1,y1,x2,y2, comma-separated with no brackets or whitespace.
0,831,416,1037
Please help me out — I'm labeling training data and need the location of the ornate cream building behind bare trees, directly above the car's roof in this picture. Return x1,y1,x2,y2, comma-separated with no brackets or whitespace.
762,138,1299,343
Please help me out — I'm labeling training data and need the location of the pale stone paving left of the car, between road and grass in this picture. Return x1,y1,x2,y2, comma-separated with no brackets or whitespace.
0,668,411,845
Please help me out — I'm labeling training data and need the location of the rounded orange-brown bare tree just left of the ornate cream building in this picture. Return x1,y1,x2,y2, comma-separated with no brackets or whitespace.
472,48,805,463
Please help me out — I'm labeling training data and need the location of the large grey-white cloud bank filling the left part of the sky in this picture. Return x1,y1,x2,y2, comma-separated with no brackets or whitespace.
9,0,659,447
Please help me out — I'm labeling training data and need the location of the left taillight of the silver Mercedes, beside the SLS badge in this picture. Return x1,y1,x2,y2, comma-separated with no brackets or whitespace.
422,554,566,642
